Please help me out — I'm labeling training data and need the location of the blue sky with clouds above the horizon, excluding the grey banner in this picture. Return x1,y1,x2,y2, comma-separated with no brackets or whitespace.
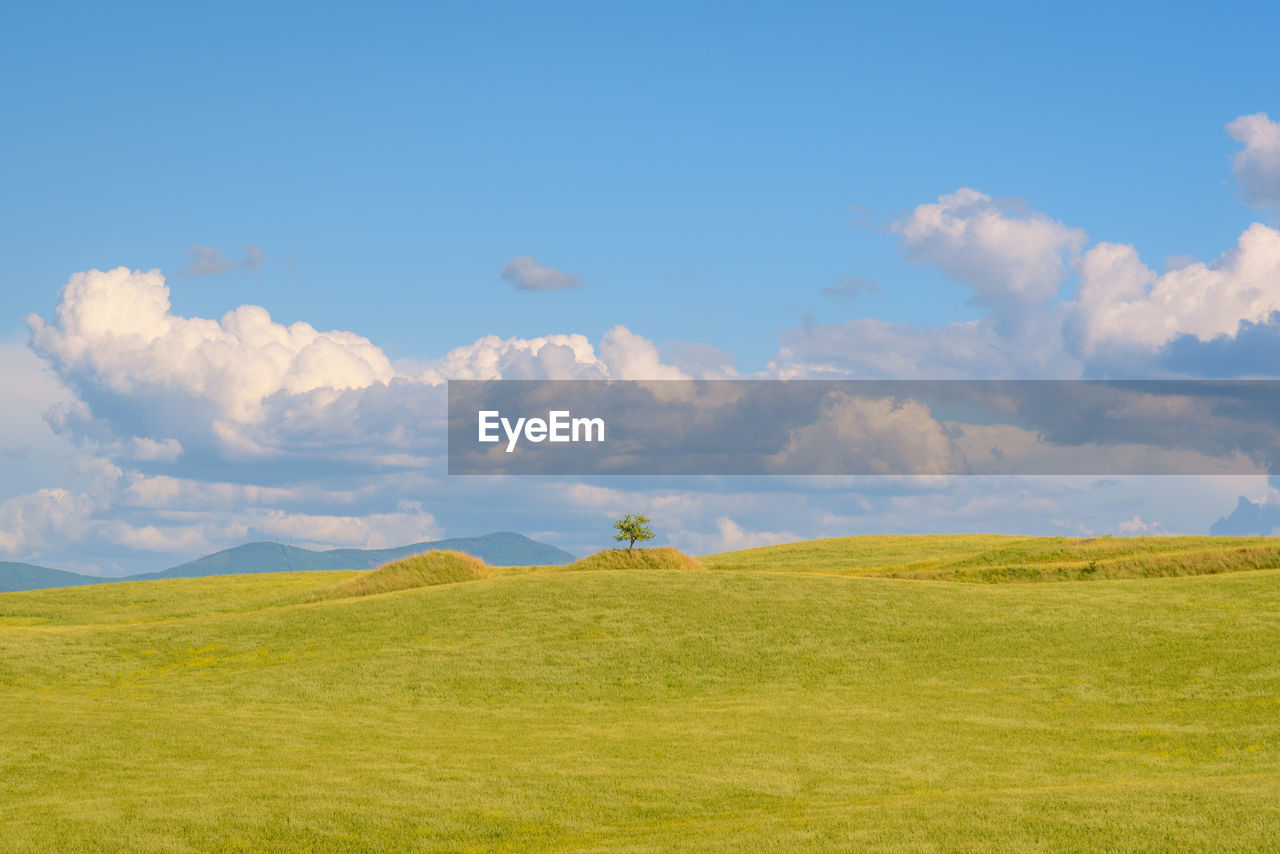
0,3,1280,575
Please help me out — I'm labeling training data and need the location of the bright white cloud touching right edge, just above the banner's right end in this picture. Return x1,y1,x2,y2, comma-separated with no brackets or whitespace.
1073,223,1280,356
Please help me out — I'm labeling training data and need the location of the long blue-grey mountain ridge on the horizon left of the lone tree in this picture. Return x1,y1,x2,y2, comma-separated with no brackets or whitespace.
120,533,576,581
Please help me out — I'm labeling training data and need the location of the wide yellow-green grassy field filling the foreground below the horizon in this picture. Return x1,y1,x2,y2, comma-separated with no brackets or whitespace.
0,538,1280,851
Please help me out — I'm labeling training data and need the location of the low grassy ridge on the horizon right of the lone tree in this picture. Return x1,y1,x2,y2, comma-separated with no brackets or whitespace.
701,534,1280,581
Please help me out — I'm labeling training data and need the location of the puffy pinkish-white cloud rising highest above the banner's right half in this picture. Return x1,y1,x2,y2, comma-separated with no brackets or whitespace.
893,187,1087,318
